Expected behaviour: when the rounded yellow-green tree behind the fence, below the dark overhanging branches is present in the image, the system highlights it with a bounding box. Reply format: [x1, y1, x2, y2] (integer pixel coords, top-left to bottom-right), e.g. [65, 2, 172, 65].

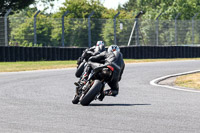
[9, 8, 52, 46]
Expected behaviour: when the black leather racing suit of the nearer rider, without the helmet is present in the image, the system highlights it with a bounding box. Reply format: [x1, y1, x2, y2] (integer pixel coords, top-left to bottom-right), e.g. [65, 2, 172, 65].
[88, 51, 125, 96]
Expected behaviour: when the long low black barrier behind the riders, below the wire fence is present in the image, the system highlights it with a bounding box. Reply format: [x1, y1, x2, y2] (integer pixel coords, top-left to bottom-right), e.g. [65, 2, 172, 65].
[0, 46, 200, 62]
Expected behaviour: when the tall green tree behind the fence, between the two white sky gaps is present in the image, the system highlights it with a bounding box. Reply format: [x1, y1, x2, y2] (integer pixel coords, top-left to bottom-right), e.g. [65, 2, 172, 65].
[52, 0, 105, 47]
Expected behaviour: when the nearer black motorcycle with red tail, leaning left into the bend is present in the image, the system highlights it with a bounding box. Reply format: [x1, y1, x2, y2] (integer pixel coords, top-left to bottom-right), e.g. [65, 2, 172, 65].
[72, 65, 114, 106]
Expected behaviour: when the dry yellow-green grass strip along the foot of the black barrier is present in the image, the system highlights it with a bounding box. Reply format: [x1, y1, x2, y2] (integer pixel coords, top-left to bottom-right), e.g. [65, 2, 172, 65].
[0, 58, 200, 72]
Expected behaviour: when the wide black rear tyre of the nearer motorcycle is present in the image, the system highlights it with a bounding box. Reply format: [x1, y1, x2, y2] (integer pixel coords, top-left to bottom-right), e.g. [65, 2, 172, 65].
[80, 80, 103, 106]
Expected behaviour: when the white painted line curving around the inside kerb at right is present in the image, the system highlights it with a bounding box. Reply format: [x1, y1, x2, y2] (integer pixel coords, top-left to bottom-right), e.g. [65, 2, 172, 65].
[150, 70, 200, 93]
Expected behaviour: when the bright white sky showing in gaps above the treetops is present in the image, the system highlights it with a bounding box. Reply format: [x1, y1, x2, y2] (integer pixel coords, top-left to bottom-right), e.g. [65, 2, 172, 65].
[37, 0, 129, 12]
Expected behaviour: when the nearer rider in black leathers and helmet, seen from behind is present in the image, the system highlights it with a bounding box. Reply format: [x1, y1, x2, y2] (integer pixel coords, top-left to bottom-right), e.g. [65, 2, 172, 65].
[80, 45, 125, 101]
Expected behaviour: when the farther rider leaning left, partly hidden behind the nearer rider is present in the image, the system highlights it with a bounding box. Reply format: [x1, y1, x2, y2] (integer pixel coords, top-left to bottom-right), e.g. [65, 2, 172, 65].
[75, 41, 105, 77]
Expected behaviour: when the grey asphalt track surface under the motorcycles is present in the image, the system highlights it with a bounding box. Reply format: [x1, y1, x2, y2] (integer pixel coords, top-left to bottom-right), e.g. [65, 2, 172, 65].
[0, 60, 200, 133]
